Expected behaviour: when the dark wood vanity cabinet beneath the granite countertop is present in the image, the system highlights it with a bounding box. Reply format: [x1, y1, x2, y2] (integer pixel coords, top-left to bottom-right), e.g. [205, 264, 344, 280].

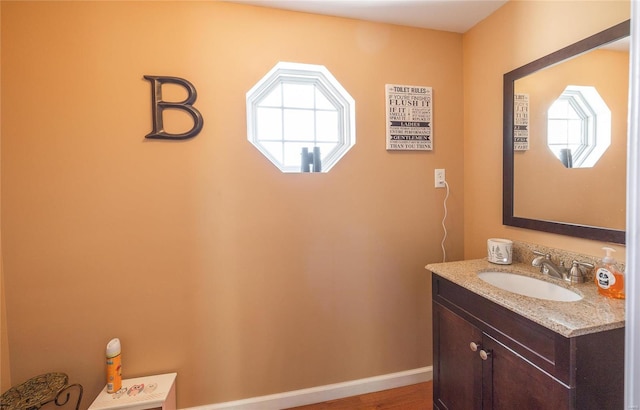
[433, 274, 624, 410]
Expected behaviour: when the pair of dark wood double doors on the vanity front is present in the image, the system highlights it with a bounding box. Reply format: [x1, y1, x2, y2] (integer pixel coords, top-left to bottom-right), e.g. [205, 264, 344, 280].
[434, 303, 571, 410]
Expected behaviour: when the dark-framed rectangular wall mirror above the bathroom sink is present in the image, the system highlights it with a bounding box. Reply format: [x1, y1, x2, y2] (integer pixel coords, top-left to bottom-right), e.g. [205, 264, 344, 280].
[503, 20, 630, 244]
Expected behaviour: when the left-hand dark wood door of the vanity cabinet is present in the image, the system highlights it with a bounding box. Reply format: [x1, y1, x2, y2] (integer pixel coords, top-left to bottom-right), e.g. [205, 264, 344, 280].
[433, 303, 482, 410]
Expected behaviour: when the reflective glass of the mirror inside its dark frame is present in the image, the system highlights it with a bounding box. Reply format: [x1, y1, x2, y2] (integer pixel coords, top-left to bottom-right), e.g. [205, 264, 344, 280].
[514, 36, 629, 229]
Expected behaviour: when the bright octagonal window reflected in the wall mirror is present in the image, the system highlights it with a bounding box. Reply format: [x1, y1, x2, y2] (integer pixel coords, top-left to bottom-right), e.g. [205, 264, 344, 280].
[547, 85, 611, 168]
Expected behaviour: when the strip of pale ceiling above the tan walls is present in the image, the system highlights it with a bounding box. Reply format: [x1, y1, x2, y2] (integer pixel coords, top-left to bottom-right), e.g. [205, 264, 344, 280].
[227, 0, 507, 33]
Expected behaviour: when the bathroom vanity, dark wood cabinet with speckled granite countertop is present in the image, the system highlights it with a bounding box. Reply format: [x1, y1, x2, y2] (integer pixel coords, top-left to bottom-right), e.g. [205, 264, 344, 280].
[427, 259, 624, 410]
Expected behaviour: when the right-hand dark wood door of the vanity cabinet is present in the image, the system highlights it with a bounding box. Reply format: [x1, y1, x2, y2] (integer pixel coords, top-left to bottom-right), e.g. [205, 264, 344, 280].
[476, 334, 573, 410]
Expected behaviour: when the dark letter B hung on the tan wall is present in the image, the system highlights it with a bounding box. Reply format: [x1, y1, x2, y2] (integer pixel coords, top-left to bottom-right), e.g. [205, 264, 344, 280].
[144, 75, 204, 140]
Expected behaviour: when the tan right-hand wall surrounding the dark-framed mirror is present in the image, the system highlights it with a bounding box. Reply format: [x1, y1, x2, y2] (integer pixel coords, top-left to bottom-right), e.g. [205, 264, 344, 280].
[463, 1, 630, 260]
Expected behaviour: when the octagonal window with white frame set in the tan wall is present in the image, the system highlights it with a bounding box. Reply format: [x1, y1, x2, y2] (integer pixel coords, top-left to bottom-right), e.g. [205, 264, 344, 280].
[247, 62, 356, 172]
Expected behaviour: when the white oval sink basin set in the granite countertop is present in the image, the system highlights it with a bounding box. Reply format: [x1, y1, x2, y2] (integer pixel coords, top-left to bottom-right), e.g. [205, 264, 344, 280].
[478, 272, 582, 302]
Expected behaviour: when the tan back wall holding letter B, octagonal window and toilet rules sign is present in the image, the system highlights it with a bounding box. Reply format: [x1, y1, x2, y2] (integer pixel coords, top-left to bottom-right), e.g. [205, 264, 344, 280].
[1, 1, 462, 407]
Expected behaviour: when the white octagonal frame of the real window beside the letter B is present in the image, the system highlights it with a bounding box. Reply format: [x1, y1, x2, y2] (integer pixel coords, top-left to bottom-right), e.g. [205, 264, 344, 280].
[246, 62, 356, 172]
